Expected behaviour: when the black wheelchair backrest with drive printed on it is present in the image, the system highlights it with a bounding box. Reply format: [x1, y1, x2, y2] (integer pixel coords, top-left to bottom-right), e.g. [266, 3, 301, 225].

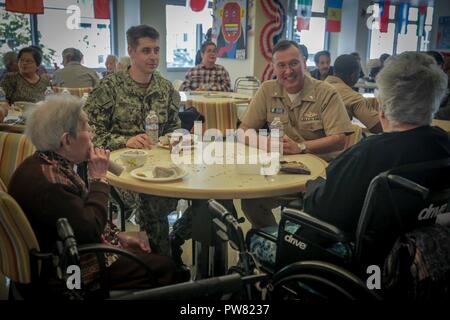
[354, 158, 450, 269]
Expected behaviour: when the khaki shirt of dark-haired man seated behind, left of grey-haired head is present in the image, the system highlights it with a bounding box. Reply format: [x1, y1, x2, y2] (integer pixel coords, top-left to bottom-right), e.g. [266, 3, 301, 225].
[325, 76, 379, 129]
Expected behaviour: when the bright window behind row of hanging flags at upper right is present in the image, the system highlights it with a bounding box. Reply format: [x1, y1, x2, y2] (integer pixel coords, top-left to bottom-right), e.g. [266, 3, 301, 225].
[369, 6, 433, 59]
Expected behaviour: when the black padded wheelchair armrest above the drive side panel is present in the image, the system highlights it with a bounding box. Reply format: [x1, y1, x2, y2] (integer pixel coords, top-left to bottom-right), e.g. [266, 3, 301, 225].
[282, 208, 350, 242]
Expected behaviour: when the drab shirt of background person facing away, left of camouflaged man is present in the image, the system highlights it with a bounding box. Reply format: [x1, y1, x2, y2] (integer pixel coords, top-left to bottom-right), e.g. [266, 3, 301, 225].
[53, 61, 100, 88]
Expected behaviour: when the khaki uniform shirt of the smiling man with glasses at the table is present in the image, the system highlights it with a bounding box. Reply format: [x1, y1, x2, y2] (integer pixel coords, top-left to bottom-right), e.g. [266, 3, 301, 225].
[242, 76, 353, 142]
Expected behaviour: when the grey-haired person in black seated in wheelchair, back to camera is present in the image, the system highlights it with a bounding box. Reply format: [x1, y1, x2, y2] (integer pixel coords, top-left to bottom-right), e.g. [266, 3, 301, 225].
[304, 52, 450, 234]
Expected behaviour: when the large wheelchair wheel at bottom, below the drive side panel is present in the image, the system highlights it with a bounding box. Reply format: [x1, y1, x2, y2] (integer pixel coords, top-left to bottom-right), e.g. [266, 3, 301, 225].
[270, 261, 381, 302]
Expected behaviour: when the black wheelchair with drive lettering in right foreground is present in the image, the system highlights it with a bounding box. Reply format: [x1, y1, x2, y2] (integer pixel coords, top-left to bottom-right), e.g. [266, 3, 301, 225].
[113, 159, 450, 303]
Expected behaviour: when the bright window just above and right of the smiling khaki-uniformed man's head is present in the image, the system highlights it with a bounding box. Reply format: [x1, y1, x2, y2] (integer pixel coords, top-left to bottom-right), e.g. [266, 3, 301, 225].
[293, 0, 328, 66]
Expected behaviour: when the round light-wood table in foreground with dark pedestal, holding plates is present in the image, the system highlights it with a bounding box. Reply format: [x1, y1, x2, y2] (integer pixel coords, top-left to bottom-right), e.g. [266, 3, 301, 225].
[107, 142, 327, 279]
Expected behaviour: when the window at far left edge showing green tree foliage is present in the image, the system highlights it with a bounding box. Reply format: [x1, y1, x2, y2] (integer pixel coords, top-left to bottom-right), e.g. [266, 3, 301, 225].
[0, 0, 31, 68]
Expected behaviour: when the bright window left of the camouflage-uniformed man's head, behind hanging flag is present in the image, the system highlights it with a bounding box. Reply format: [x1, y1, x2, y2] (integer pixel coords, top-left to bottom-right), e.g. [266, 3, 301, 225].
[37, 0, 111, 68]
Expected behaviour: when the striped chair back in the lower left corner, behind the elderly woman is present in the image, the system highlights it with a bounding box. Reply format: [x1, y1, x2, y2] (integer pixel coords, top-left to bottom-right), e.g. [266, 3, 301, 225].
[0, 192, 39, 284]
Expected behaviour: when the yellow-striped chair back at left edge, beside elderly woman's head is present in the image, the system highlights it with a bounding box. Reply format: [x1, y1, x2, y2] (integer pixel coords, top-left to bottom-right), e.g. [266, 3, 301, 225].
[0, 132, 35, 186]
